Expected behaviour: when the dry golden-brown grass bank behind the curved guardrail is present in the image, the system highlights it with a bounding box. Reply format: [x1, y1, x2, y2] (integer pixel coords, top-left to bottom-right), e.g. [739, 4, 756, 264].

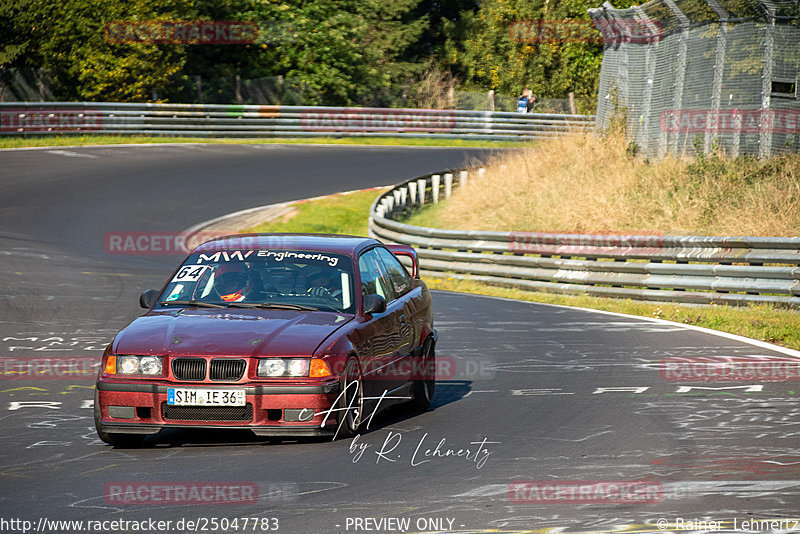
[428, 133, 800, 236]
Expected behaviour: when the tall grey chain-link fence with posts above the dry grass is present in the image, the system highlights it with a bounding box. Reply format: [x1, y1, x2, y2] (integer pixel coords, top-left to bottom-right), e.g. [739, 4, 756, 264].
[589, 0, 800, 157]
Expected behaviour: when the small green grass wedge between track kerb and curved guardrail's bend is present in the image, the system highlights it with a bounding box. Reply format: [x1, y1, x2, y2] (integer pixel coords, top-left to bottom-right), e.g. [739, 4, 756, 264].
[242, 189, 379, 236]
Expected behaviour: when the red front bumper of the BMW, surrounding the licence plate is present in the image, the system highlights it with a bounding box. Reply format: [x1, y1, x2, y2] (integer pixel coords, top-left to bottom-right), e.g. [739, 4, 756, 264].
[96, 379, 339, 436]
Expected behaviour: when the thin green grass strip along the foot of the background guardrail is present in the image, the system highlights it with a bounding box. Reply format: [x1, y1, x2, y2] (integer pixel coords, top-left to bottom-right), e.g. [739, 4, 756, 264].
[0, 135, 528, 149]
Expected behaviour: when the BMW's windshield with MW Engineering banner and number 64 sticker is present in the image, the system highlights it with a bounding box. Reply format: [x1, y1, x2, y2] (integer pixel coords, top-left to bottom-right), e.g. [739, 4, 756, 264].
[156, 250, 355, 313]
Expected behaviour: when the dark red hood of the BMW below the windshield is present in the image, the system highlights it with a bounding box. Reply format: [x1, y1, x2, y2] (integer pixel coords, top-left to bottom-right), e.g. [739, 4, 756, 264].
[113, 309, 353, 356]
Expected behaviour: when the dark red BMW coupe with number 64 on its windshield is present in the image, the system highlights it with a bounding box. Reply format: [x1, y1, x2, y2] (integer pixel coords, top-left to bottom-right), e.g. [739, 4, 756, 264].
[94, 234, 436, 446]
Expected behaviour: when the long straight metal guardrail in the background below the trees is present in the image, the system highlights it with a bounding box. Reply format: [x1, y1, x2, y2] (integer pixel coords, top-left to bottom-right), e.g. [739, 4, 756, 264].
[0, 102, 594, 140]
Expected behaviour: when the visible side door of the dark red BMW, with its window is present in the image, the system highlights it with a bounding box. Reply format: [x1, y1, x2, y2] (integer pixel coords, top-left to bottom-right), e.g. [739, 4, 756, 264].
[358, 248, 404, 396]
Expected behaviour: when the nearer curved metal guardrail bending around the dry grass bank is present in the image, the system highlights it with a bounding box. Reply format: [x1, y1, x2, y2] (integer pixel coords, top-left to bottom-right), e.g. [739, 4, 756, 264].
[369, 169, 800, 308]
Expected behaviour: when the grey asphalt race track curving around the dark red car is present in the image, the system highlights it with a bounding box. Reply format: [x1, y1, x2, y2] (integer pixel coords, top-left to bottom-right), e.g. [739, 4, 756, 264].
[0, 145, 800, 534]
